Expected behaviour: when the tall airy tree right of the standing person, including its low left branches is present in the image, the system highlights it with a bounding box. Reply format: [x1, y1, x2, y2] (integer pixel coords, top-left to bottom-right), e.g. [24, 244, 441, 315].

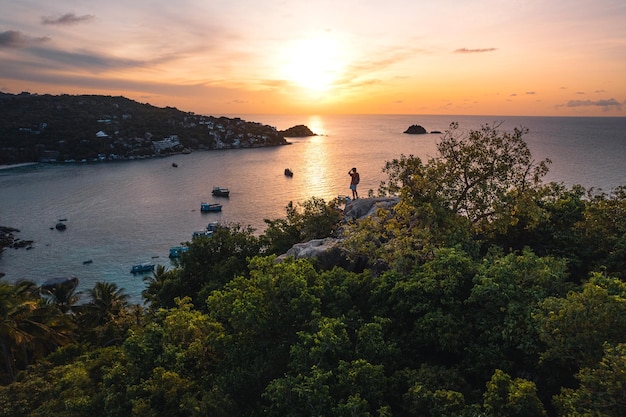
[381, 123, 550, 234]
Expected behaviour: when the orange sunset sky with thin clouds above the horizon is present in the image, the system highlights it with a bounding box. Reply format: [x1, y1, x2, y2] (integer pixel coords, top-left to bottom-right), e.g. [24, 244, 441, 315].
[0, 0, 626, 117]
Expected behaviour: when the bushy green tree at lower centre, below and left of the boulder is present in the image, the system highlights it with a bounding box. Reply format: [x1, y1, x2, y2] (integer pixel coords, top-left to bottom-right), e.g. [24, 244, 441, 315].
[207, 256, 322, 414]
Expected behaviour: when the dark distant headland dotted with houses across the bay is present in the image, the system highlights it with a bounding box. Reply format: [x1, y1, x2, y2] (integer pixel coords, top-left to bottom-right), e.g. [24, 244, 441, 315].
[0, 93, 288, 164]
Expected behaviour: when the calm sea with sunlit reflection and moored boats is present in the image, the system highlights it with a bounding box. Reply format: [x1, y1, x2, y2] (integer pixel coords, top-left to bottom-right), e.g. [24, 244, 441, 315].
[0, 115, 626, 304]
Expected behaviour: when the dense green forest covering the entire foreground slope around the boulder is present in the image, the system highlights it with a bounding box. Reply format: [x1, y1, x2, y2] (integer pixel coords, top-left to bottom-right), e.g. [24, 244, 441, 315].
[0, 124, 626, 417]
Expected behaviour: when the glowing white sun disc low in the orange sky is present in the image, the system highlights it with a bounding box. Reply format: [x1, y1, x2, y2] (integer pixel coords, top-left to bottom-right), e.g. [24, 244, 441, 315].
[280, 36, 345, 92]
